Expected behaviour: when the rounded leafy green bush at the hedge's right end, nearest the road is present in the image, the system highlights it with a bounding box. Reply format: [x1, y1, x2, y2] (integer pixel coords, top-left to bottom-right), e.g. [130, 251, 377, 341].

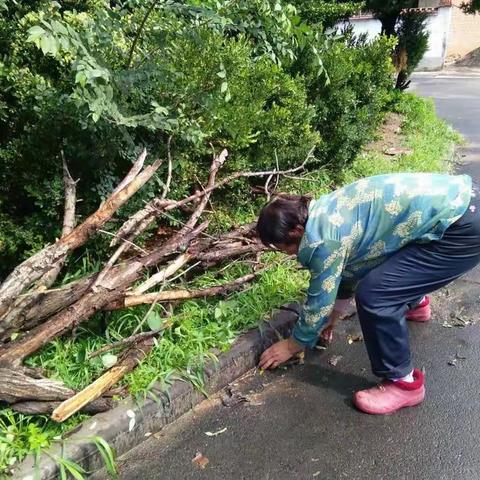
[302, 32, 394, 172]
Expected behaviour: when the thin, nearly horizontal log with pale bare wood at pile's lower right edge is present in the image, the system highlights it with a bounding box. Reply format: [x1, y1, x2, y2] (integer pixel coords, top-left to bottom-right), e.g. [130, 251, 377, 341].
[105, 273, 256, 310]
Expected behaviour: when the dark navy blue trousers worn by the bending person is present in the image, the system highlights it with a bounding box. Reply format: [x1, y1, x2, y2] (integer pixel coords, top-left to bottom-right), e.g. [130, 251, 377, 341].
[355, 188, 480, 379]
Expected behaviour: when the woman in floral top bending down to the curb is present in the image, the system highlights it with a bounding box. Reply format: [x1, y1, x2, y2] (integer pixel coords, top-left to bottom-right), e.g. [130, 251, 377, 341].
[257, 173, 480, 414]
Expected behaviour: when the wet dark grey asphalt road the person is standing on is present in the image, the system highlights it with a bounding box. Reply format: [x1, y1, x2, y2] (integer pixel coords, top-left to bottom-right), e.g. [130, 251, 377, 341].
[94, 74, 480, 480]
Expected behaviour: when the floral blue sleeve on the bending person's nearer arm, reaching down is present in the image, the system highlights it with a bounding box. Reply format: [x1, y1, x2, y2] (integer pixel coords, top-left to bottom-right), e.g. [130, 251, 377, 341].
[292, 241, 346, 348]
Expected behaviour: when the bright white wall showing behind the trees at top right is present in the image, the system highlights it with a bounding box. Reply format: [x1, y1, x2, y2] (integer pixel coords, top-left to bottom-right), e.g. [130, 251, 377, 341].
[337, 7, 452, 70]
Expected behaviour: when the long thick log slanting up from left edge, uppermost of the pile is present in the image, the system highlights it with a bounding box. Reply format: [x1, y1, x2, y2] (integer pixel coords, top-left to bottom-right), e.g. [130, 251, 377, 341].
[0, 152, 161, 318]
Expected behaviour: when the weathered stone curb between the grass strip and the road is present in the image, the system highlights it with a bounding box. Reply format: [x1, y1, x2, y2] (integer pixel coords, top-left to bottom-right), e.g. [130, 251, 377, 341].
[13, 304, 299, 480]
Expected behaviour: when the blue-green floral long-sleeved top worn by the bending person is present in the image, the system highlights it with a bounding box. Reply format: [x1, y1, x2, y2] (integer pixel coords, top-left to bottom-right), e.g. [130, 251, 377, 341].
[293, 173, 472, 347]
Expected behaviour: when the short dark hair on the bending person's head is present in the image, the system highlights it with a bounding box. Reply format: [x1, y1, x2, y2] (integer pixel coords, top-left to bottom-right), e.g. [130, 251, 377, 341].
[257, 194, 311, 245]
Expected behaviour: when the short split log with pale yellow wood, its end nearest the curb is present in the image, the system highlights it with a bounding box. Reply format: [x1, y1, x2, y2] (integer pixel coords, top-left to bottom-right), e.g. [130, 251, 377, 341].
[52, 338, 154, 422]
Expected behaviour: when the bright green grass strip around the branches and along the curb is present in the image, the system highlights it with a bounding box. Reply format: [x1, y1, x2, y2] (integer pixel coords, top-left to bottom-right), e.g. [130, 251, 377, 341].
[0, 94, 461, 478]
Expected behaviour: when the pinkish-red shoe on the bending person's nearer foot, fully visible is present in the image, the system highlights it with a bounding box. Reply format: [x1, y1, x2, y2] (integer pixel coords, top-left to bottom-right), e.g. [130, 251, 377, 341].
[353, 369, 425, 415]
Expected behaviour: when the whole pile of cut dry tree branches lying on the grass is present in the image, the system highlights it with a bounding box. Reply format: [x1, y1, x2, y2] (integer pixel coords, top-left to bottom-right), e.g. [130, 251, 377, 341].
[0, 145, 311, 421]
